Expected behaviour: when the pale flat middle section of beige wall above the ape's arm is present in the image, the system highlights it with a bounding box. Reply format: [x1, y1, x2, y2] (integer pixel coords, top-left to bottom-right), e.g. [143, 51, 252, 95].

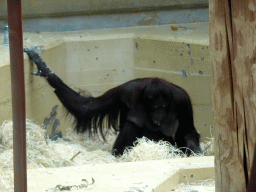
[63, 35, 134, 96]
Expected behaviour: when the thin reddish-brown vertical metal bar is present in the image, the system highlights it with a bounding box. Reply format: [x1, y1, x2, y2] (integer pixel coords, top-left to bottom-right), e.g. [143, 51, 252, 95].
[7, 0, 27, 192]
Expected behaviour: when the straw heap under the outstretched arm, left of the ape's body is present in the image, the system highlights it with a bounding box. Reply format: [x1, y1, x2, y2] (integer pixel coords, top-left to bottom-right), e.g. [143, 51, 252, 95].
[0, 120, 115, 168]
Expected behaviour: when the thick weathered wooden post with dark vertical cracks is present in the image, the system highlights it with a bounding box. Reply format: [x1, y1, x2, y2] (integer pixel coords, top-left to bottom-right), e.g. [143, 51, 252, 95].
[209, 0, 256, 191]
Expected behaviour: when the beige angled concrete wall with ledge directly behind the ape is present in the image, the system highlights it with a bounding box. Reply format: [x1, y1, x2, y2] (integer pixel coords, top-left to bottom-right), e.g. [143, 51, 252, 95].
[0, 23, 212, 142]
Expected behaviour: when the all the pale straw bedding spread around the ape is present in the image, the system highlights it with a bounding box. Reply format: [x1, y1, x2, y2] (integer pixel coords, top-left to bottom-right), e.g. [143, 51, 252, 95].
[0, 120, 214, 191]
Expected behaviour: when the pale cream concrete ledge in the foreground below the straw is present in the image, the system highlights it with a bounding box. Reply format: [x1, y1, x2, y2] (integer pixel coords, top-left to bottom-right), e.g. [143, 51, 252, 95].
[17, 156, 214, 192]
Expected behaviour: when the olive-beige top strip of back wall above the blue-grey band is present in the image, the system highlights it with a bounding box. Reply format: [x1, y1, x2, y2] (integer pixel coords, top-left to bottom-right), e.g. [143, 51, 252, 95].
[0, 0, 208, 20]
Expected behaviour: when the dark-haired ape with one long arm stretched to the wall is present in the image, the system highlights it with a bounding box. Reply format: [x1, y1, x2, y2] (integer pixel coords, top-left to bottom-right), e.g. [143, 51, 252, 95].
[24, 48, 201, 155]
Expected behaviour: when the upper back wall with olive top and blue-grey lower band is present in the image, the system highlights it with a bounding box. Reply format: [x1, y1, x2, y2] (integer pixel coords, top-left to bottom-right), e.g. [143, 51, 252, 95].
[0, 0, 209, 32]
